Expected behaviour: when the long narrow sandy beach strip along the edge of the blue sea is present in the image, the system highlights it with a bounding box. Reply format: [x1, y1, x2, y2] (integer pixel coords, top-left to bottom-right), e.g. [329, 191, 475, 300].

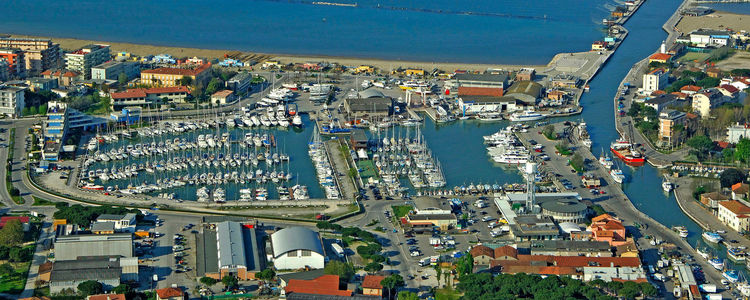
[4, 34, 545, 72]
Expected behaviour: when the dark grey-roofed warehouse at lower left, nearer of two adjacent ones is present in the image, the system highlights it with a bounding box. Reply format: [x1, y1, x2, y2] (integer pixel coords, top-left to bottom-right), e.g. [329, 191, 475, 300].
[48, 257, 138, 293]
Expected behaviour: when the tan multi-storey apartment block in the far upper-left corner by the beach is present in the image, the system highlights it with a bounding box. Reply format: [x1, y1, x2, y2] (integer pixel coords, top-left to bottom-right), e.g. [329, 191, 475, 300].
[0, 37, 62, 75]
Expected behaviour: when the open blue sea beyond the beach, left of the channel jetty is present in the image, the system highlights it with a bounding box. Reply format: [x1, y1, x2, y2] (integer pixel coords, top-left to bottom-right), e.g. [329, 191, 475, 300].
[0, 0, 622, 64]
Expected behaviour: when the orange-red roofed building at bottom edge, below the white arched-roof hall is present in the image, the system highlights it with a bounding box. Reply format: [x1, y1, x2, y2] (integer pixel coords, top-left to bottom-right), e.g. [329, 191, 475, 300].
[284, 275, 354, 300]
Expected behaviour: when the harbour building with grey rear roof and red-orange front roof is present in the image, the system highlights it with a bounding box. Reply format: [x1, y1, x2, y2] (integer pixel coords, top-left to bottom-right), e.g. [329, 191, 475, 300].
[451, 73, 508, 97]
